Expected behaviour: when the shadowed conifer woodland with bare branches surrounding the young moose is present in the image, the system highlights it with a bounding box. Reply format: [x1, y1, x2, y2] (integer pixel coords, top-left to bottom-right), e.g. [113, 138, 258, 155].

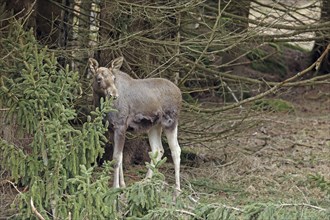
[0, 0, 330, 219]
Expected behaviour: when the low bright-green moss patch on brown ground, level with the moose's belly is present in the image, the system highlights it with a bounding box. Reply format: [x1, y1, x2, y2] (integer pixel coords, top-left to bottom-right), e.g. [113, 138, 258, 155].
[252, 99, 295, 112]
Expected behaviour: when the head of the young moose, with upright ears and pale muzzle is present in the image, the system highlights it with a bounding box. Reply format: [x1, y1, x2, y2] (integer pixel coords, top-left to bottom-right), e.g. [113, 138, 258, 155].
[88, 57, 124, 99]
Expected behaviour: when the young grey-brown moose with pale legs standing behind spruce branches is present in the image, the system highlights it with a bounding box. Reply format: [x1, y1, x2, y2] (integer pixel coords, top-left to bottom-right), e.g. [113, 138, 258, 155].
[89, 57, 182, 192]
